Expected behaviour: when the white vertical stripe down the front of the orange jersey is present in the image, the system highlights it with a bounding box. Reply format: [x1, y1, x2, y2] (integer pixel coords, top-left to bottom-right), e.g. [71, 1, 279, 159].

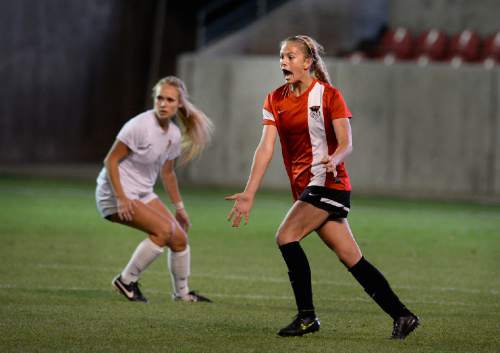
[307, 82, 328, 186]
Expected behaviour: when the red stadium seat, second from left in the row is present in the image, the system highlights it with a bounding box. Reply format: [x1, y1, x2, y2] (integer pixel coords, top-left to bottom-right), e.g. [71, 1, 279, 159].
[415, 29, 449, 65]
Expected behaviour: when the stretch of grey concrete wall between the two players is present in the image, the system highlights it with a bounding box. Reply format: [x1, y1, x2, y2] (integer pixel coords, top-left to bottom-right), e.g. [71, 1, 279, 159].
[178, 56, 288, 188]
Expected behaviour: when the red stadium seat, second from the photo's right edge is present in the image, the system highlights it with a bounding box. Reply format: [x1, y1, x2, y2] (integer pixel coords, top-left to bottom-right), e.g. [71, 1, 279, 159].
[449, 29, 481, 65]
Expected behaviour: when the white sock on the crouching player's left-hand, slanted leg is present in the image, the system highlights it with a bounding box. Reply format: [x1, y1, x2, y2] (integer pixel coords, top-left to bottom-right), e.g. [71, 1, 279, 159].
[121, 238, 163, 284]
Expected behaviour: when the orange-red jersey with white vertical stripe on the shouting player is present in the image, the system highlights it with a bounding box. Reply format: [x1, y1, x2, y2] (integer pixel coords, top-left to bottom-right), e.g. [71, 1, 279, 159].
[262, 80, 352, 199]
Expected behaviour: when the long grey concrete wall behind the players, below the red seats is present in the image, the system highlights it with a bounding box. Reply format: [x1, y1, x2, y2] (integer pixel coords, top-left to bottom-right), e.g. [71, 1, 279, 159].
[178, 55, 500, 200]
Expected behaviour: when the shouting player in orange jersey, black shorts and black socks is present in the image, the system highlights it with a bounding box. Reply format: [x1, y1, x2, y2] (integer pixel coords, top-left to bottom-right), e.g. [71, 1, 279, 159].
[226, 35, 419, 339]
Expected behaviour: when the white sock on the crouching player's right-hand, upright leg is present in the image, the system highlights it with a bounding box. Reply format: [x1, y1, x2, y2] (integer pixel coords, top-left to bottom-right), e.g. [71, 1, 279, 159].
[168, 245, 191, 297]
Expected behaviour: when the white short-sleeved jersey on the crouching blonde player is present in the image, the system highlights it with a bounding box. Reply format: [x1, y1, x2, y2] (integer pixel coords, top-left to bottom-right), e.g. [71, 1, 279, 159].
[97, 110, 182, 199]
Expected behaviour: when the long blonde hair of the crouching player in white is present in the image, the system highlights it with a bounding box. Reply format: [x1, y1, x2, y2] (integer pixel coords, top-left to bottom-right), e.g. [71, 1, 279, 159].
[153, 76, 214, 163]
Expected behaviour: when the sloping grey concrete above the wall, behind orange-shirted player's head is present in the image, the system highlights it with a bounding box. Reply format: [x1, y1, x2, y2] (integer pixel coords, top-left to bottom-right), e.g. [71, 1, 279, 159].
[199, 0, 389, 56]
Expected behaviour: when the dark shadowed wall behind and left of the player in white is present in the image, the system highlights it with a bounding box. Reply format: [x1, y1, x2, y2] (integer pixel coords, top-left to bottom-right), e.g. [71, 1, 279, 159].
[0, 0, 208, 164]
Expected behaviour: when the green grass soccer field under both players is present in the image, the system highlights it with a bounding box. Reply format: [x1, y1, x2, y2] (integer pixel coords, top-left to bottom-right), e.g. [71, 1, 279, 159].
[0, 176, 500, 353]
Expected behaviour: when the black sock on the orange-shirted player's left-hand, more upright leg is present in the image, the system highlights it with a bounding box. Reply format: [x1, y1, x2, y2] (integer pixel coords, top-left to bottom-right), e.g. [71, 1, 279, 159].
[279, 241, 315, 316]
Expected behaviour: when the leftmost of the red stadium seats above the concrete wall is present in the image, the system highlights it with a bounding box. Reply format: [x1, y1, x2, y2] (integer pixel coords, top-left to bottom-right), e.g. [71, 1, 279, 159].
[379, 27, 413, 62]
